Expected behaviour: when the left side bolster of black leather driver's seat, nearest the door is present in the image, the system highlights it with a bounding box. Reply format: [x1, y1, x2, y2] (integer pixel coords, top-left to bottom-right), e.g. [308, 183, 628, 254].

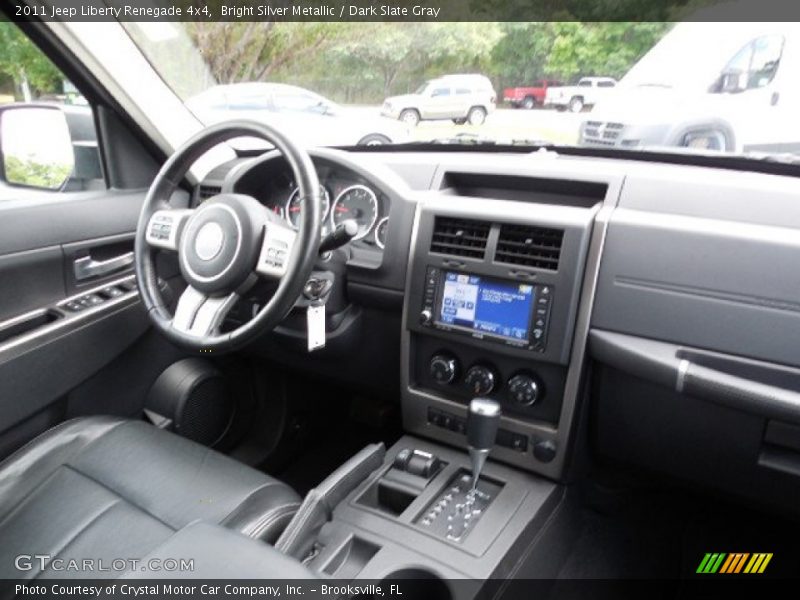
[0, 416, 125, 519]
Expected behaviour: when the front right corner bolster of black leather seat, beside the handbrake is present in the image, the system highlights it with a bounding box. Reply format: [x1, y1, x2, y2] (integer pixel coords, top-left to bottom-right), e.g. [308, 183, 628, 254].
[221, 480, 301, 544]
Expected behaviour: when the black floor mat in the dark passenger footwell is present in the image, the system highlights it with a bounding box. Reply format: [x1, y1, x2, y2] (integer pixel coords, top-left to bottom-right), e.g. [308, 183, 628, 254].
[559, 482, 800, 580]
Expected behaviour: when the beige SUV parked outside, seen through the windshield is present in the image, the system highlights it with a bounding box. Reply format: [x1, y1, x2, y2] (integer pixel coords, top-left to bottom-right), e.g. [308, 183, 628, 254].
[381, 75, 497, 126]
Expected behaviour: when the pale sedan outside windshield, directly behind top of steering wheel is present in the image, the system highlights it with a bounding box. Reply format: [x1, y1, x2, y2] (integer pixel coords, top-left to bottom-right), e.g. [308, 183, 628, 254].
[186, 82, 408, 146]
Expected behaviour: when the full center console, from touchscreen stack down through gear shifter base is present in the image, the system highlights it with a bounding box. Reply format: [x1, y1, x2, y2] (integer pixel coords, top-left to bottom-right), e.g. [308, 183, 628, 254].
[279, 165, 619, 600]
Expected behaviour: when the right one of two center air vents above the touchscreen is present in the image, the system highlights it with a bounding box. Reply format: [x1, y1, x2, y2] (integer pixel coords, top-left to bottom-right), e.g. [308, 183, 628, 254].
[494, 225, 564, 271]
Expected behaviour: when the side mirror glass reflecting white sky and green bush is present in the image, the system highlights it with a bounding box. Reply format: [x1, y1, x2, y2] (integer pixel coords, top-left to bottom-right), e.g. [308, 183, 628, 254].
[0, 104, 75, 190]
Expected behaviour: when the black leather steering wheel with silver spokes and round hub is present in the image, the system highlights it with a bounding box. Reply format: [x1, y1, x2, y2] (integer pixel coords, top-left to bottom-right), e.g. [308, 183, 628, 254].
[134, 120, 322, 353]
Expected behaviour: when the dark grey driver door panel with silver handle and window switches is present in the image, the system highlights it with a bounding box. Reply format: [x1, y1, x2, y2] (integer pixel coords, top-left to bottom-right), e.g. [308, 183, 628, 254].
[0, 190, 148, 456]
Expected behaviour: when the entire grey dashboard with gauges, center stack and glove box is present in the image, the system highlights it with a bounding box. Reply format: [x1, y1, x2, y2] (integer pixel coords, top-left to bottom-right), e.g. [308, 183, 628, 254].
[195, 148, 800, 509]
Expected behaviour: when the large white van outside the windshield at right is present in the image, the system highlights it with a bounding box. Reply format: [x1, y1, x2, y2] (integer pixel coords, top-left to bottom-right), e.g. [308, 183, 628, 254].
[580, 22, 800, 153]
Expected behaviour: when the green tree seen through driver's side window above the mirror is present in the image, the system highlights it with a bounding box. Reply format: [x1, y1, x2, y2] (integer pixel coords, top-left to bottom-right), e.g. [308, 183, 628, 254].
[0, 21, 64, 101]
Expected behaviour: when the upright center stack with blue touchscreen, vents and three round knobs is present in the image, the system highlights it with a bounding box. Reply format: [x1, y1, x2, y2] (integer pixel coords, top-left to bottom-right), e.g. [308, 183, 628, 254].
[402, 177, 603, 477]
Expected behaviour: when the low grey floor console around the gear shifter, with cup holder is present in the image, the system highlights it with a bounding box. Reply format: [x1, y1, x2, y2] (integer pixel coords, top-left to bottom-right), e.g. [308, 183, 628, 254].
[305, 436, 563, 599]
